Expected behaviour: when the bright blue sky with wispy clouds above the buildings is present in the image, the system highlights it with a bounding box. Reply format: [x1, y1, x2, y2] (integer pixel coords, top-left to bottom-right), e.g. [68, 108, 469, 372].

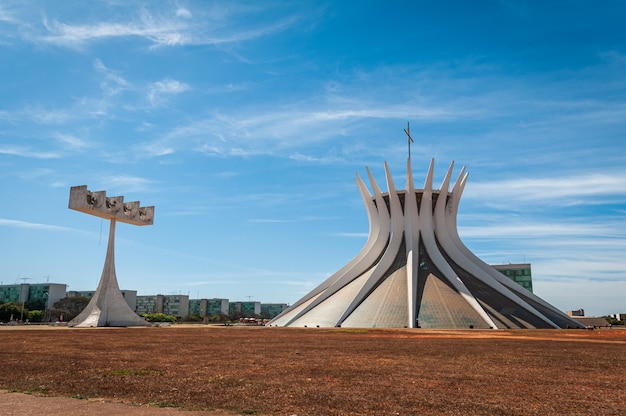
[0, 0, 626, 315]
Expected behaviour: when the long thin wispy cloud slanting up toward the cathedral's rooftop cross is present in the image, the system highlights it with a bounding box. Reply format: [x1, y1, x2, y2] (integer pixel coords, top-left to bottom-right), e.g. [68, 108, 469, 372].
[141, 100, 459, 158]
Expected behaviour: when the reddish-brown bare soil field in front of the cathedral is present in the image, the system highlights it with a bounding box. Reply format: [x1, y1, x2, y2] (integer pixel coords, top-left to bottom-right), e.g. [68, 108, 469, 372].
[0, 326, 626, 416]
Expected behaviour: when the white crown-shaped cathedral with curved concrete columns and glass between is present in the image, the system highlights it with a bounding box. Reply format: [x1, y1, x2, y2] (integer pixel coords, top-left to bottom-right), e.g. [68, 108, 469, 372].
[269, 158, 582, 329]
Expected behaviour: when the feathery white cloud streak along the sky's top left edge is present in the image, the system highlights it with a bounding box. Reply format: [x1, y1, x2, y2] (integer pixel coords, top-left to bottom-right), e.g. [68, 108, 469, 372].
[14, 3, 302, 49]
